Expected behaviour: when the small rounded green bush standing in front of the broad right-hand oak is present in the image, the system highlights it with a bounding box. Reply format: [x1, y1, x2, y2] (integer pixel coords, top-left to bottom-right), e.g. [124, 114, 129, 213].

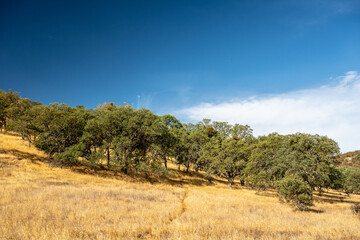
[277, 176, 312, 210]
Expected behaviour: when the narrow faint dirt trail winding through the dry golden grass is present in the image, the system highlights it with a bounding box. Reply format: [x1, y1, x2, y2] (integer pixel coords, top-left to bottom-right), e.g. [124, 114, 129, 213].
[138, 188, 189, 239]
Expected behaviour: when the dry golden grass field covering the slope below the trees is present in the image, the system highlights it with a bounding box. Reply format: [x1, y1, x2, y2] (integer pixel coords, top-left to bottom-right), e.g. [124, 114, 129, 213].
[0, 134, 360, 240]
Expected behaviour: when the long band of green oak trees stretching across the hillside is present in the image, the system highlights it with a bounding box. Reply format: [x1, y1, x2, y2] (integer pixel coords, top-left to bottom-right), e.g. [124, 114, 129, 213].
[0, 90, 360, 209]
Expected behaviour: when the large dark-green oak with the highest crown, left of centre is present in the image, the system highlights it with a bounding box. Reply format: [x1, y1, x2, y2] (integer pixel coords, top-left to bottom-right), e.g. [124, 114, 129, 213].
[80, 104, 169, 173]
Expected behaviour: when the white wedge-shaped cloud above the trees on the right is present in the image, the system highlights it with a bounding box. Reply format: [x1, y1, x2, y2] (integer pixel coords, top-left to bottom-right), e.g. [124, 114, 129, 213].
[177, 71, 360, 152]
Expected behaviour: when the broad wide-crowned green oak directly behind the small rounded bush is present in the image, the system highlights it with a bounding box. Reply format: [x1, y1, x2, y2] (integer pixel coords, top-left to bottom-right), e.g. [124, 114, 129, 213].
[245, 133, 341, 192]
